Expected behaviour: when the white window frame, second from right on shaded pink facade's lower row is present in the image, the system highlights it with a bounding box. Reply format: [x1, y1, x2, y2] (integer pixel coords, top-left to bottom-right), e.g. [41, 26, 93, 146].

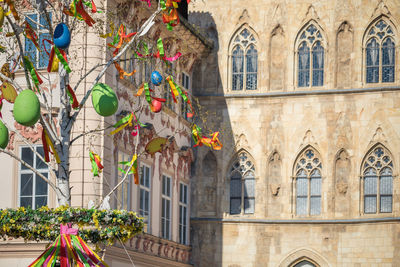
[160, 174, 172, 240]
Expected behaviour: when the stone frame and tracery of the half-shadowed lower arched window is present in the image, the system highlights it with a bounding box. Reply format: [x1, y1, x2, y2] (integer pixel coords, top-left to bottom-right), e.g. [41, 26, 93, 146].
[227, 149, 257, 215]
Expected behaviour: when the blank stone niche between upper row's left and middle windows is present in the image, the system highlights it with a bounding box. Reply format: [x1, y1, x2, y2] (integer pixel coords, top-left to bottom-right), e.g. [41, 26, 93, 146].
[269, 24, 287, 91]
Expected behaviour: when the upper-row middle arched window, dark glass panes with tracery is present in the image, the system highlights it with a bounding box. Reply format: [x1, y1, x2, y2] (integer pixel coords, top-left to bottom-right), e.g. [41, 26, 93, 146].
[297, 24, 324, 87]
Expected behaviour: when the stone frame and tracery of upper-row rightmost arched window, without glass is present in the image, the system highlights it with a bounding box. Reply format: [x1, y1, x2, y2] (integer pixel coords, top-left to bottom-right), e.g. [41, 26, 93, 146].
[361, 15, 399, 87]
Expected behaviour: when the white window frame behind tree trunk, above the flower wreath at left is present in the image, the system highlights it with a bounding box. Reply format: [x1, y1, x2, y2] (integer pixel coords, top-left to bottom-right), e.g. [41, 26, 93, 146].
[18, 145, 49, 209]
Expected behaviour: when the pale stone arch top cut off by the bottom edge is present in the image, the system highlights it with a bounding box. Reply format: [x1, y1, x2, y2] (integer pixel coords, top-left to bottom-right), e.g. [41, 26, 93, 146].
[278, 248, 330, 267]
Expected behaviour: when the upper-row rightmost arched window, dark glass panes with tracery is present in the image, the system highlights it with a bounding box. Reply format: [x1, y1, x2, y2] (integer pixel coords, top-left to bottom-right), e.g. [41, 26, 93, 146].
[365, 19, 395, 83]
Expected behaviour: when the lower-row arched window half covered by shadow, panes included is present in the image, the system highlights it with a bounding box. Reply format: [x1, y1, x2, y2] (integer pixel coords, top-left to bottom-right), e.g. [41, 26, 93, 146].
[229, 152, 255, 214]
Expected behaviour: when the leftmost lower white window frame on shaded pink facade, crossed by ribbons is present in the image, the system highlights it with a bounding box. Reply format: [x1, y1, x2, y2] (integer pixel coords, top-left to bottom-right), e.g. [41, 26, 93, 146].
[116, 151, 132, 211]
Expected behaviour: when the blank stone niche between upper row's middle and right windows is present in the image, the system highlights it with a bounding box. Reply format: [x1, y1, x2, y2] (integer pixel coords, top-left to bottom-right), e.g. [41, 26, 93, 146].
[335, 21, 354, 88]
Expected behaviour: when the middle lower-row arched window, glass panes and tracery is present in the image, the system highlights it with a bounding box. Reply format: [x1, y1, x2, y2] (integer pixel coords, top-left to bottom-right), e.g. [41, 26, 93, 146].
[294, 147, 322, 215]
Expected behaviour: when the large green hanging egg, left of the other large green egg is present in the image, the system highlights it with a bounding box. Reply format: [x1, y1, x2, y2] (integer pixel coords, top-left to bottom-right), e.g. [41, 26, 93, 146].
[13, 89, 40, 126]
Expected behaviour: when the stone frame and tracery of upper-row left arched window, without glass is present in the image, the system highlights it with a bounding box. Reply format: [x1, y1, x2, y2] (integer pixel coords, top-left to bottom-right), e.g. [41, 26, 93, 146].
[227, 23, 261, 93]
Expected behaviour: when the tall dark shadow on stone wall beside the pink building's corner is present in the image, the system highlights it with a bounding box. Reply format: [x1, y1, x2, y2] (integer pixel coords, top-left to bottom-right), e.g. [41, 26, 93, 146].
[189, 12, 233, 267]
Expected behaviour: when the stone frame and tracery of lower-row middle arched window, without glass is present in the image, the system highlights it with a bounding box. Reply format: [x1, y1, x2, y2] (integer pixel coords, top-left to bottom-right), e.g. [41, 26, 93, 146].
[292, 145, 324, 217]
